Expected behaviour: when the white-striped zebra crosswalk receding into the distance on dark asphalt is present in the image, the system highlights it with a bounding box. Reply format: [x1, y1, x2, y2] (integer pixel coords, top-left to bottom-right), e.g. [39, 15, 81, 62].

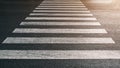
[0, 0, 120, 66]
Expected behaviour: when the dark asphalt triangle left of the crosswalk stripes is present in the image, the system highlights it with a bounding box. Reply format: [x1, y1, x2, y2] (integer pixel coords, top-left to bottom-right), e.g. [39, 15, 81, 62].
[0, 0, 42, 42]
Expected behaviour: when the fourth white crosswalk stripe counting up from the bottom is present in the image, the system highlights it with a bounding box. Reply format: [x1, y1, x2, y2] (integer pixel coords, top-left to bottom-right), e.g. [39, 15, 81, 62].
[20, 22, 101, 26]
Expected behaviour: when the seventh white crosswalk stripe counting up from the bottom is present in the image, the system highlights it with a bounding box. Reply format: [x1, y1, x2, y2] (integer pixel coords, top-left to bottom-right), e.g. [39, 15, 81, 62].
[33, 10, 90, 13]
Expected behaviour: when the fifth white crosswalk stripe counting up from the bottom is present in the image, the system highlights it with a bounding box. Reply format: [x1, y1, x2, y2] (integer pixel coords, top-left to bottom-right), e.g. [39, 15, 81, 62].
[25, 17, 96, 20]
